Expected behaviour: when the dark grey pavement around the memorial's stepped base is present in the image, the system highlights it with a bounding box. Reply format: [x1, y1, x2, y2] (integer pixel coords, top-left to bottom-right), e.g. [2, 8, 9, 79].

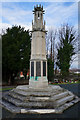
[0, 84, 80, 120]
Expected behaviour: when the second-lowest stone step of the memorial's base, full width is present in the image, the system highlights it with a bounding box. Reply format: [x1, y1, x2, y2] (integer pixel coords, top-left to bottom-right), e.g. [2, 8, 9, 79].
[3, 92, 74, 108]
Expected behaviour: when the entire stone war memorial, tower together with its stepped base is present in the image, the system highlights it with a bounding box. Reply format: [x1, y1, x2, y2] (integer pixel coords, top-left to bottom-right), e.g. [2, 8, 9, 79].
[0, 5, 80, 114]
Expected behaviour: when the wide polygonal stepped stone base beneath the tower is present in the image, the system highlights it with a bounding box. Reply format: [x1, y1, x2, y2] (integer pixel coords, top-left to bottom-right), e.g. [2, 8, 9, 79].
[0, 85, 80, 114]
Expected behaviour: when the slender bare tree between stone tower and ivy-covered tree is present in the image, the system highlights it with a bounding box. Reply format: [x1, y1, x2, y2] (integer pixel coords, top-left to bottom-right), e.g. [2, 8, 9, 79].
[46, 29, 56, 81]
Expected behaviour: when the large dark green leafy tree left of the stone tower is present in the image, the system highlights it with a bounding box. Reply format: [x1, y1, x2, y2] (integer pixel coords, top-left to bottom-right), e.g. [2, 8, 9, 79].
[2, 26, 31, 83]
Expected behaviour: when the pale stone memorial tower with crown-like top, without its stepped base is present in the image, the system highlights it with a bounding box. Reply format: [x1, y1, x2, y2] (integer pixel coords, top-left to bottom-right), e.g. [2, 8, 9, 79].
[29, 5, 48, 88]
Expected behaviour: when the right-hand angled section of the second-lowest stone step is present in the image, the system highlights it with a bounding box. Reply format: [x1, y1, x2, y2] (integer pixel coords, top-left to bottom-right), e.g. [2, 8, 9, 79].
[54, 95, 75, 107]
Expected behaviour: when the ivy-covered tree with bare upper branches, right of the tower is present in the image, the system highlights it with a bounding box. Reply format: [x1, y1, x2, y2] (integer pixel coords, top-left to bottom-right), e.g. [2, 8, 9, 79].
[56, 24, 76, 78]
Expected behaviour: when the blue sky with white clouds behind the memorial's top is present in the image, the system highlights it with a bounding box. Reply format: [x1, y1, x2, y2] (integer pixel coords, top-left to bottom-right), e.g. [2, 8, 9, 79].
[0, 0, 78, 68]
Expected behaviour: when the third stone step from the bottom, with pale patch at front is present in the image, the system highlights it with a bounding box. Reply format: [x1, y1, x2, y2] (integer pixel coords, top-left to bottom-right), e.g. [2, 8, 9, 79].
[9, 91, 69, 102]
